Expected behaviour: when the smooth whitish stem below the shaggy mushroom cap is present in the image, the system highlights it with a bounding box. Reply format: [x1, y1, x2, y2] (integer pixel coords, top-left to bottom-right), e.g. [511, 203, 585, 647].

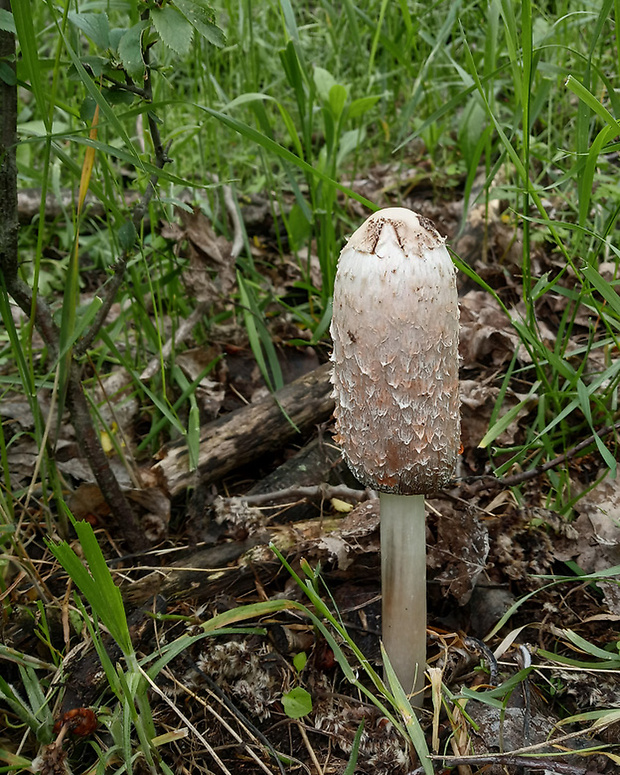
[379, 493, 426, 707]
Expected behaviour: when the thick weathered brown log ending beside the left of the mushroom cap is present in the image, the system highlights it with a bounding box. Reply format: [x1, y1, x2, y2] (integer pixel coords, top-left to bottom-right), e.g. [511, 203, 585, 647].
[153, 363, 334, 496]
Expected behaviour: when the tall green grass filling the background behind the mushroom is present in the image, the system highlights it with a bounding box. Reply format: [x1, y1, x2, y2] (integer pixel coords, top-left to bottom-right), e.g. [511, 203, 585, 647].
[2, 0, 620, 556]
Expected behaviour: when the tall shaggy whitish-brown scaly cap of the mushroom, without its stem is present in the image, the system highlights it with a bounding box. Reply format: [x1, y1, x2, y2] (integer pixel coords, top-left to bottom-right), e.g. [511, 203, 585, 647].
[331, 207, 460, 495]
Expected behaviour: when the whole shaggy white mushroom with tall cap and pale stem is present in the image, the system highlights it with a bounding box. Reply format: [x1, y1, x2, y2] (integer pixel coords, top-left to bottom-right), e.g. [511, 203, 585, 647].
[331, 207, 460, 705]
